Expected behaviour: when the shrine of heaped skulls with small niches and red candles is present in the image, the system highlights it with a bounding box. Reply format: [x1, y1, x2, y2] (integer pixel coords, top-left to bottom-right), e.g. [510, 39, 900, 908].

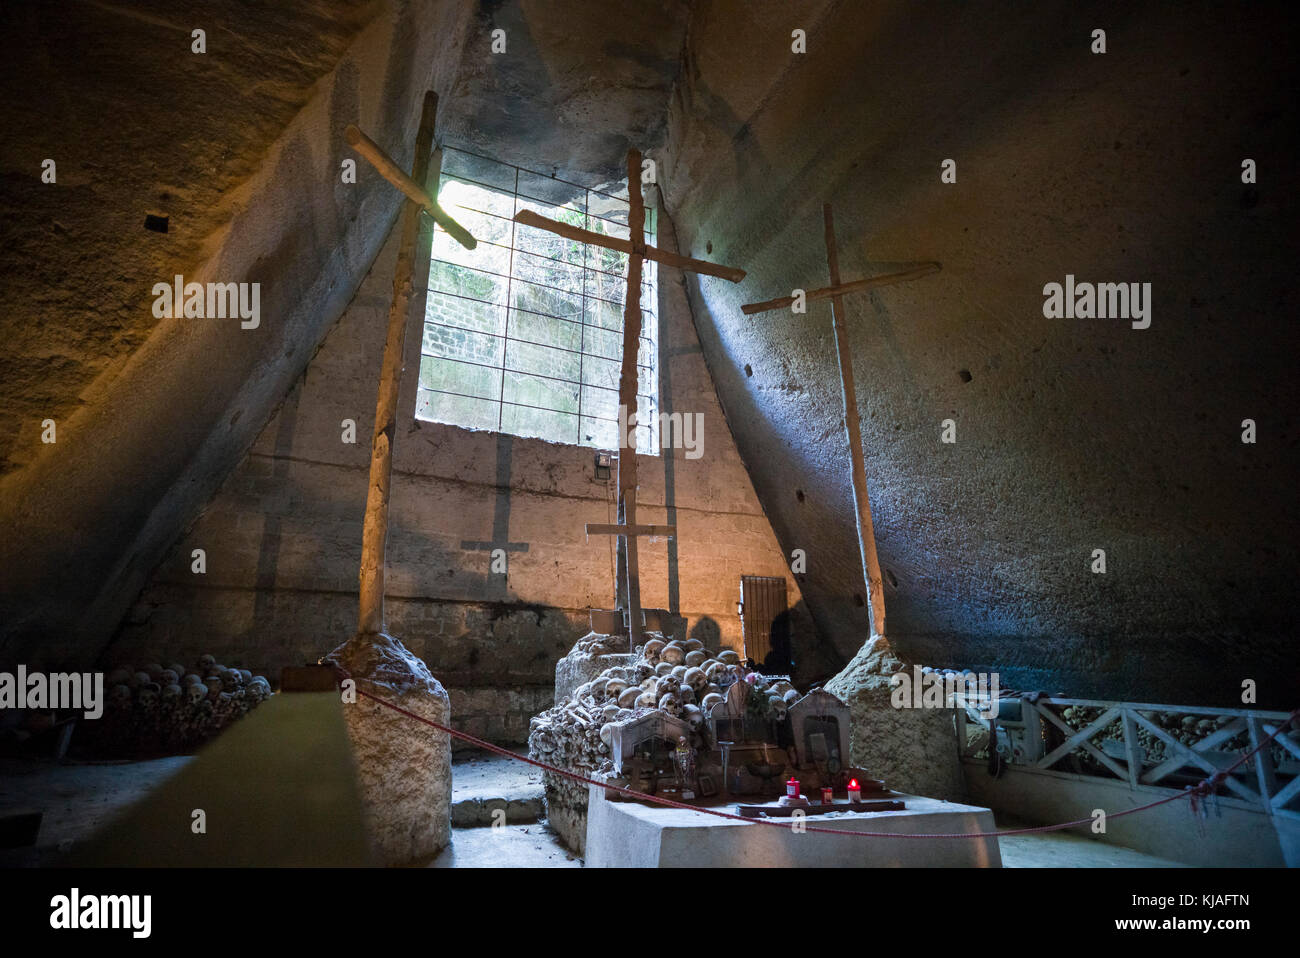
[529, 636, 904, 818]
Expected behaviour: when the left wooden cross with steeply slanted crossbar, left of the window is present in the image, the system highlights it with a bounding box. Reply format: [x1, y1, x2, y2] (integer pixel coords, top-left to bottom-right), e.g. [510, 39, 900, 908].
[347, 91, 475, 634]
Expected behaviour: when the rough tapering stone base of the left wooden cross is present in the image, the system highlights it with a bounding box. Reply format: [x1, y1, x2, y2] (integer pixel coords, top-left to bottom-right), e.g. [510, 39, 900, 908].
[321, 633, 451, 864]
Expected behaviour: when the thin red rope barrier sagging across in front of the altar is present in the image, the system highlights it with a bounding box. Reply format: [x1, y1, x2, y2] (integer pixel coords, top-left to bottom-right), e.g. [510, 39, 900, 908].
[335, 668, 1300, 838]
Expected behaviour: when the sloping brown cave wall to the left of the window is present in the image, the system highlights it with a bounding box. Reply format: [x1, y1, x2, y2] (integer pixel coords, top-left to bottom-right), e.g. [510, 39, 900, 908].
[0, 0, 472, 668]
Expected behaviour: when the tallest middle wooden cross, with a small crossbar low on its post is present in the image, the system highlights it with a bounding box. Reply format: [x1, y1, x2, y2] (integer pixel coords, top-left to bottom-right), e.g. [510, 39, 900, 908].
[515, 149, 745, 647]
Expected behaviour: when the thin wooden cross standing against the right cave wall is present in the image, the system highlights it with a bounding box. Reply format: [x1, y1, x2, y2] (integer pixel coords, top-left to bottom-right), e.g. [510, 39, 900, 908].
[741, 203, 940, 636]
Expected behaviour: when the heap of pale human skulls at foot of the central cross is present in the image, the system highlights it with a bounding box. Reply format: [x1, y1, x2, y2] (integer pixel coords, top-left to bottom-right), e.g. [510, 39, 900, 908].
[528, 638, 801, 771]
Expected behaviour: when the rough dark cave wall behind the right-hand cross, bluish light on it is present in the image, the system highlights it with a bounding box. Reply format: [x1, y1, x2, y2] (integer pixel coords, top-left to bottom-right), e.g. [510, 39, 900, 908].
[662, 0, 1300, 707]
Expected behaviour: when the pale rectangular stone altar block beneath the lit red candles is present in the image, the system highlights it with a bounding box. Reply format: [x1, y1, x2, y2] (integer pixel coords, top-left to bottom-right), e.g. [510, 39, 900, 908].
[586, 785, 1002, 868]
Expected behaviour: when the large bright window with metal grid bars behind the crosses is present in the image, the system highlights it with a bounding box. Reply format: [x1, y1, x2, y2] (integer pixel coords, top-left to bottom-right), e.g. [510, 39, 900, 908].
[415, 146, 659, 454]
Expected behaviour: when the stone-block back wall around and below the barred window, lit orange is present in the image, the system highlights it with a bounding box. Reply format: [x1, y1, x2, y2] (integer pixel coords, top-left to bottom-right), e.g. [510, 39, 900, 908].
[105, 210, 835, 744]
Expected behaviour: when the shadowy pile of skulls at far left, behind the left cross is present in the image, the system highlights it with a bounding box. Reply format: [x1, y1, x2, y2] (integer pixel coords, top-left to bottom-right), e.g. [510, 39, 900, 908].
[86, 655, 272, 755]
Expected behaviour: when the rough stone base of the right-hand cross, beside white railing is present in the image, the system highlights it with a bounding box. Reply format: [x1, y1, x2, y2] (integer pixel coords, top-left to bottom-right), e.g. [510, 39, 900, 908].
[826, 638, 966, 801]
